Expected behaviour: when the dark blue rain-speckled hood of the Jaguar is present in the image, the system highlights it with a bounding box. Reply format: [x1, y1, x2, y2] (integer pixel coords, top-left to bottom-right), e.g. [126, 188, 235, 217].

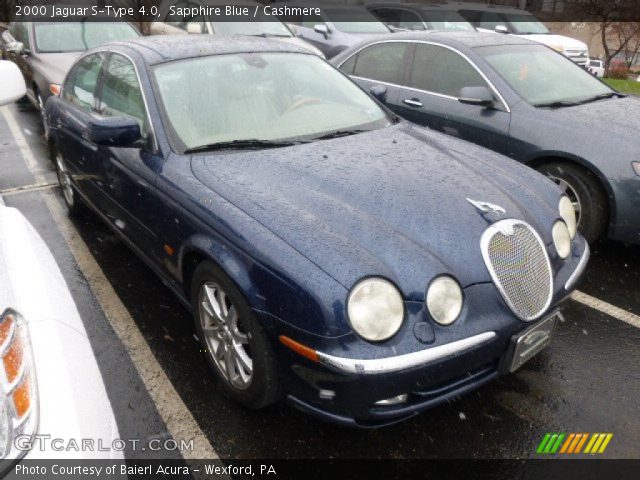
[191, 122, 560, 300]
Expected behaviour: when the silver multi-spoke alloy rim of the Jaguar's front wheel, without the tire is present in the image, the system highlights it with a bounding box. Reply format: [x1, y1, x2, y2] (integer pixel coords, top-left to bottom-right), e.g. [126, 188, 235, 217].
[198, 282, 253, 390]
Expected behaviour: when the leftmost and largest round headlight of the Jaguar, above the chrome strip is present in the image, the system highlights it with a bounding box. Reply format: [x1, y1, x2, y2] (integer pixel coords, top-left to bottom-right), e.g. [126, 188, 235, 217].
[347, 278, 404, 342]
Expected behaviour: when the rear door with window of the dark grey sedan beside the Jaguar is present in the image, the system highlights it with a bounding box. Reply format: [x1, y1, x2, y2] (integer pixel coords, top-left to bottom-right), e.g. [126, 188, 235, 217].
[340, 41, 411, 113]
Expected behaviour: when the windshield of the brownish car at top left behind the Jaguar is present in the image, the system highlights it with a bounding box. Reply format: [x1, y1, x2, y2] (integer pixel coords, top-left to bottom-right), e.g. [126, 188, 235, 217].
[35, 22, 140, 53]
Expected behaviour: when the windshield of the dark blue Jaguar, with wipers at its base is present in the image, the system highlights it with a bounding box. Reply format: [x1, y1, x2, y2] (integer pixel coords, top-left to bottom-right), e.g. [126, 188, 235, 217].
[154, 52, 392, 151]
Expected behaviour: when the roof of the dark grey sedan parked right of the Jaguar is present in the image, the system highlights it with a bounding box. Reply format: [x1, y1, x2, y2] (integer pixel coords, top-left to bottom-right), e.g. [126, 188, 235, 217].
[356, 31, 540, 48]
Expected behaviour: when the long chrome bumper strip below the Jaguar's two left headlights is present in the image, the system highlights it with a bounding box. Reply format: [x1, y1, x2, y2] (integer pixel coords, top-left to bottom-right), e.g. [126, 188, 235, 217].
[317, 332, 497, 375]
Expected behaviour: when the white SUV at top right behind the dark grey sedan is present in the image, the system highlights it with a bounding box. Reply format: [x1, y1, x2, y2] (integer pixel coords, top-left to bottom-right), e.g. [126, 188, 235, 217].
[446, 1, 589, 68]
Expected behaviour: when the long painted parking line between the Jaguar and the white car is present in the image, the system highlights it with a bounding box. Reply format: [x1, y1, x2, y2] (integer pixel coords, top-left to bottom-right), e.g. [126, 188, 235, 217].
[0, 107, 218, 460]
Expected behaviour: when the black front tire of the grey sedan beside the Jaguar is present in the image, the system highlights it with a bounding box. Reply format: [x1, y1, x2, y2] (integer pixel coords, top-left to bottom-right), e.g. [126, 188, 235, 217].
[538, 162, 609, 244]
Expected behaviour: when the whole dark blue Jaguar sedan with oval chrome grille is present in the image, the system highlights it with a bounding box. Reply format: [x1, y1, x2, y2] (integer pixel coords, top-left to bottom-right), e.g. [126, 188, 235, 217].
[47, 36, 589, 426]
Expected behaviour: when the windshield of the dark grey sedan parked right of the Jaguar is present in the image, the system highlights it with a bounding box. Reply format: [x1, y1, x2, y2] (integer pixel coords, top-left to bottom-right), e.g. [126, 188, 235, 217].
[476, 45, 615, 106]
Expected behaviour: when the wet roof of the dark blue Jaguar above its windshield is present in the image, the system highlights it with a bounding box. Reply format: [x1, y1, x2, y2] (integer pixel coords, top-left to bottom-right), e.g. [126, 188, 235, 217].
[101, 34, 313, 65]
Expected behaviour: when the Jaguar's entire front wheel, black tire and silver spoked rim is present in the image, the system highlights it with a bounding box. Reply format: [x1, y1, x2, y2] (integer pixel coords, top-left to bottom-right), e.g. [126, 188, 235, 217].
[191, 261, 282, 409]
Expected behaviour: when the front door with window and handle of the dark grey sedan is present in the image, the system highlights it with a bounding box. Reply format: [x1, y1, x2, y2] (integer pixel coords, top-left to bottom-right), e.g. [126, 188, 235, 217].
[397, 43, 511, 153]
